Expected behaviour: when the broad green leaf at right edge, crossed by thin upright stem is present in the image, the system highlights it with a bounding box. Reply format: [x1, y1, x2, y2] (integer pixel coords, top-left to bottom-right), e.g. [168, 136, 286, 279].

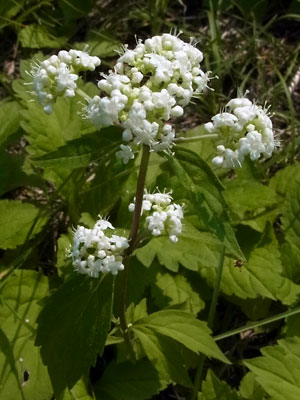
[200, 245, 300, 305]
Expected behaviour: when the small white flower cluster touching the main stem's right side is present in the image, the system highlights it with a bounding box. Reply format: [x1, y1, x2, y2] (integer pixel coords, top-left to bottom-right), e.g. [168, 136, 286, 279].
[128, 190, 183, 243]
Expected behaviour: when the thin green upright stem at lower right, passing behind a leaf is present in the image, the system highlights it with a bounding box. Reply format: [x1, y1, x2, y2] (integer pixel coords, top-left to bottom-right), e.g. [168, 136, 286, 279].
[191, 244, 225, 400]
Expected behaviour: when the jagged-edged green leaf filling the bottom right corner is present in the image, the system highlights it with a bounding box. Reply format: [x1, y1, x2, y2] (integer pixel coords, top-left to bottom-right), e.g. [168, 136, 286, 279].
[243, 337, 300, 400]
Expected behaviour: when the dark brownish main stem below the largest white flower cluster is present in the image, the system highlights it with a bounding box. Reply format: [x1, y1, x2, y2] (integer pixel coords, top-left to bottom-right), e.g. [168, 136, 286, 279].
[120, 145, 150, 336]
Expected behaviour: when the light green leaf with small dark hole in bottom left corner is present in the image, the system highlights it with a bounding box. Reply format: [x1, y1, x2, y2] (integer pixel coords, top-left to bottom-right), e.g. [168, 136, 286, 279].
[0, 270, 53, 400]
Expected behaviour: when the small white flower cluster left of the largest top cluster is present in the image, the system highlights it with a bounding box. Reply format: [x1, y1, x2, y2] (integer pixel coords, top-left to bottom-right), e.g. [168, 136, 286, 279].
[31, 50, 100, 114]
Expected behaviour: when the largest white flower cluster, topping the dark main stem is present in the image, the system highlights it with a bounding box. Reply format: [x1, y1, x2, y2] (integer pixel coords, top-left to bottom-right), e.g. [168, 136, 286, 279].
[85, 34, 209, 163]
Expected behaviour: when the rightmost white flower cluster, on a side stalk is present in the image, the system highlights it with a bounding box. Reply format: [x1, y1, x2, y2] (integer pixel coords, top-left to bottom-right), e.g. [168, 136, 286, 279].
[205, 97, 276, 168]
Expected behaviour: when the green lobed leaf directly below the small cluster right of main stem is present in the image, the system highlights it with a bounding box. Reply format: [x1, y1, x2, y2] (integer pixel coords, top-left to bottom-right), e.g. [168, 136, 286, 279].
[135, 222, 220, 272]
